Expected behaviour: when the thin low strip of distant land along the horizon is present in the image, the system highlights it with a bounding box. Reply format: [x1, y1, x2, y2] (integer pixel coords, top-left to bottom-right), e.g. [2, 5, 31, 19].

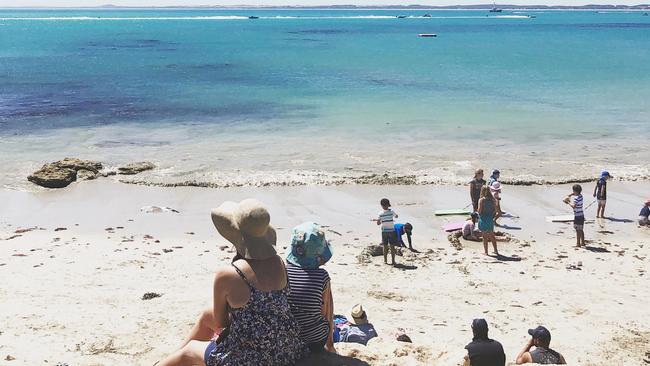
[0, 4, 650, 11]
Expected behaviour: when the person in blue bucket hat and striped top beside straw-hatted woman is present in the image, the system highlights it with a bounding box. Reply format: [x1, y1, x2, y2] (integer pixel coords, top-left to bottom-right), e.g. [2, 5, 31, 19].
[286, 222, 336, 352]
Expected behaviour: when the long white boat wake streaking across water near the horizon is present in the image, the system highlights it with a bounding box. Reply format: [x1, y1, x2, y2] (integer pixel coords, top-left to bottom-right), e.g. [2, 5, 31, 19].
[0, 15, 531, 21]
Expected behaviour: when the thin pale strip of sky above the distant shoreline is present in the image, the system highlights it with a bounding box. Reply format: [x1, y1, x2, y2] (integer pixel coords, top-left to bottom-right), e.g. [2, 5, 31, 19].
[0, 0, 647, 7]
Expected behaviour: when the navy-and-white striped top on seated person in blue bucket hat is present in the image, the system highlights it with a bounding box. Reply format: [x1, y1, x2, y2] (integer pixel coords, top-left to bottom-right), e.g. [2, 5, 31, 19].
[287, 263, 330, 344]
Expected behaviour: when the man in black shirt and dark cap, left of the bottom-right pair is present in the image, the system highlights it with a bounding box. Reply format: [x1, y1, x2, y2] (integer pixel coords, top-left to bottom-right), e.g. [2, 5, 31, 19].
[465, 319, 506, 366]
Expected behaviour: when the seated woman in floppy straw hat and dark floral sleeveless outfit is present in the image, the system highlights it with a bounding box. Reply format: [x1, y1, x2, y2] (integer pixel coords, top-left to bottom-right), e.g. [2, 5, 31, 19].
[158, 199, 307, 366]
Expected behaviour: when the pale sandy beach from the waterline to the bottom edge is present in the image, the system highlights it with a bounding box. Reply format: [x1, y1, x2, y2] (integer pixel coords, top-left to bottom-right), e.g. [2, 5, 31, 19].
[0, 181, 650, 366]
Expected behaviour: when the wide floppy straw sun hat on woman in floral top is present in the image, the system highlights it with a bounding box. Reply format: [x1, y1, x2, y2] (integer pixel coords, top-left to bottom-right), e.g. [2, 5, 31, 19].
[212, 199, 277, 259]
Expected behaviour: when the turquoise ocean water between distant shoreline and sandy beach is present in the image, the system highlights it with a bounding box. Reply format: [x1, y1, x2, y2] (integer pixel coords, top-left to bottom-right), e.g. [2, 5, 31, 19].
[0, 9, 650, 187]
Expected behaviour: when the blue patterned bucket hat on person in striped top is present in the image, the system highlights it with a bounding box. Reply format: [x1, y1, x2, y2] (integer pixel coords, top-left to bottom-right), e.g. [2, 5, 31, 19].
[287, 222, 332, 269]
